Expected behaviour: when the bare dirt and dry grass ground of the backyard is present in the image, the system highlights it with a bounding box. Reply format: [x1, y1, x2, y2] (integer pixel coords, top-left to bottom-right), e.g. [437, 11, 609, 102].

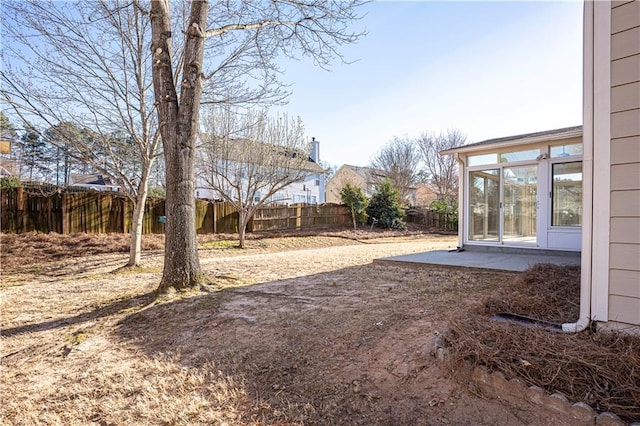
[0, 231, 596, 425]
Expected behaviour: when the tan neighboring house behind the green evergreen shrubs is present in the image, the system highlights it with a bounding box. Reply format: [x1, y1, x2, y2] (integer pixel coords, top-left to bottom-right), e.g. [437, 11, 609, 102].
[326, 164, 416, 206]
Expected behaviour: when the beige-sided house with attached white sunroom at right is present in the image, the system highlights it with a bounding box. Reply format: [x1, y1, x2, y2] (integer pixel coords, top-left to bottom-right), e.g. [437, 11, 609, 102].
[443, 0, 640, 333]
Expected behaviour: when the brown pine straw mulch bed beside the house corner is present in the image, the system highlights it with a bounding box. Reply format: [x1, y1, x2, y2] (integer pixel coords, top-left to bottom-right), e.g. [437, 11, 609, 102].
[445, 264, 640, 422]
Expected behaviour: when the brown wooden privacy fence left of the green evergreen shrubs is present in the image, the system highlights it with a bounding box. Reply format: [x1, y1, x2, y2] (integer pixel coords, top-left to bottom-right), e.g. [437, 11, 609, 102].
[0, 188, 350, 234]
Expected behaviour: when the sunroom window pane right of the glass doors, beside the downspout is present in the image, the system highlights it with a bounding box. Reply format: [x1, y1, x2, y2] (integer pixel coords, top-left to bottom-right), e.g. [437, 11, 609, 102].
[551, 161, 582, 226]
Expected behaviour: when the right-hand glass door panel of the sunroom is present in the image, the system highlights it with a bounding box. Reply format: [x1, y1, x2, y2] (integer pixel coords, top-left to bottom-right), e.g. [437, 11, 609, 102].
[502, 165, 538, 244]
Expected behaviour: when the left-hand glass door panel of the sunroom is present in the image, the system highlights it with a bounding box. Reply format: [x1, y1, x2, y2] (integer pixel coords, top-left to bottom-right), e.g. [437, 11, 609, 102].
[469, 169, 500, 241]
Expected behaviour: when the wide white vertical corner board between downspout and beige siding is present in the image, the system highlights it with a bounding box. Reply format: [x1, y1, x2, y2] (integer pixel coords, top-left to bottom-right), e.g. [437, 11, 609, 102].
[583, 0, 611, 321]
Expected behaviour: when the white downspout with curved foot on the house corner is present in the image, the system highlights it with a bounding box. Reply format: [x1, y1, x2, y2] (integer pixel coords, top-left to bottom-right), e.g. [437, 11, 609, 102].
[562, 0, 595, 333]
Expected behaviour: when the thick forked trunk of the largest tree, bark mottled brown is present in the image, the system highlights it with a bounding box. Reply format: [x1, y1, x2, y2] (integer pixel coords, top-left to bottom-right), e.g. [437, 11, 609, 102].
[151, 0, 208, 293]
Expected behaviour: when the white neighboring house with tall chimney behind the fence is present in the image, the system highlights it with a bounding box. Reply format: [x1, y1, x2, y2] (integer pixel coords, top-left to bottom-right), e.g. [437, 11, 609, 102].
[196, 138, 326, 204]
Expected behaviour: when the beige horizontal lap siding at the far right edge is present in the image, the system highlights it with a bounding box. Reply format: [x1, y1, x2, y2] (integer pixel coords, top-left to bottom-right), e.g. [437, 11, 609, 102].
[608, 1, 640, 325]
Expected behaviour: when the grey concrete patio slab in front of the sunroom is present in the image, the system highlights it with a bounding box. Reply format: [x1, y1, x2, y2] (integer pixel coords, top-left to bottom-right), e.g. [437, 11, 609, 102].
[375, 250, 580, 272]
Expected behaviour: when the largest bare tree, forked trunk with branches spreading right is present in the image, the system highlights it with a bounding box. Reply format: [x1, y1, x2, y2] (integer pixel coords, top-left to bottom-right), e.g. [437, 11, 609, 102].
[150, 0, 362, 292]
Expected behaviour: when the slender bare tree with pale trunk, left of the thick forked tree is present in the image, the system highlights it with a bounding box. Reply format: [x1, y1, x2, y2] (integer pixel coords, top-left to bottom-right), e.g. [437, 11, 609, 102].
[1, 0, 160, 266]
